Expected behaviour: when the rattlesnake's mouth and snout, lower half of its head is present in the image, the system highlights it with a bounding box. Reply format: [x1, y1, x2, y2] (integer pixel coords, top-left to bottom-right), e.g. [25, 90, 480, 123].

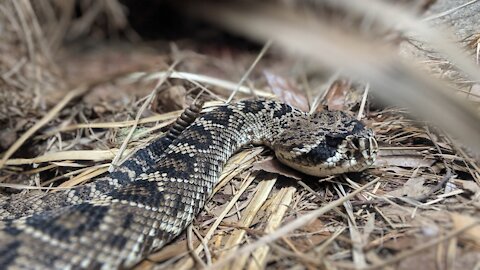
[277, 135, 378, 177]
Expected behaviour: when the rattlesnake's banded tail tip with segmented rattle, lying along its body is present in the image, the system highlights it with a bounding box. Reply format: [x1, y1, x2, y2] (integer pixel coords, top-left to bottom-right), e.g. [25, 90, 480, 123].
[0, 102, 202, 220]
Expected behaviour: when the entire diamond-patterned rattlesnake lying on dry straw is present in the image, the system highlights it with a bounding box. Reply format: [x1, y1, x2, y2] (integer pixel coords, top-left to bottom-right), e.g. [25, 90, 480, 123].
[0, 100, 378, 269]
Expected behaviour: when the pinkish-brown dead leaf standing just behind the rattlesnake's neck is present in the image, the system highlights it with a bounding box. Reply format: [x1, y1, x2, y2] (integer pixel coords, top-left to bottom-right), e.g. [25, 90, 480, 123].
[263, 70, 310, 112]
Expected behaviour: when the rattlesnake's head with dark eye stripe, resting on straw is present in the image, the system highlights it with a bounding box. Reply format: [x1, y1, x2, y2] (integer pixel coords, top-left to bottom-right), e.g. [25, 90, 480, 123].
[272, 111, 378, 176]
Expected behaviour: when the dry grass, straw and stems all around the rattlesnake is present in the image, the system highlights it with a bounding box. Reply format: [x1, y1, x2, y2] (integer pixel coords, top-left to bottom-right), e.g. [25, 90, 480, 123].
[0, 0, 480, 269]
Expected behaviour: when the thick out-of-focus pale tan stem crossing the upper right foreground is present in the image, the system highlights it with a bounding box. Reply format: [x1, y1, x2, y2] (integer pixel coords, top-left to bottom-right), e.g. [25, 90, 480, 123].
[184, 0, 480, 151]
